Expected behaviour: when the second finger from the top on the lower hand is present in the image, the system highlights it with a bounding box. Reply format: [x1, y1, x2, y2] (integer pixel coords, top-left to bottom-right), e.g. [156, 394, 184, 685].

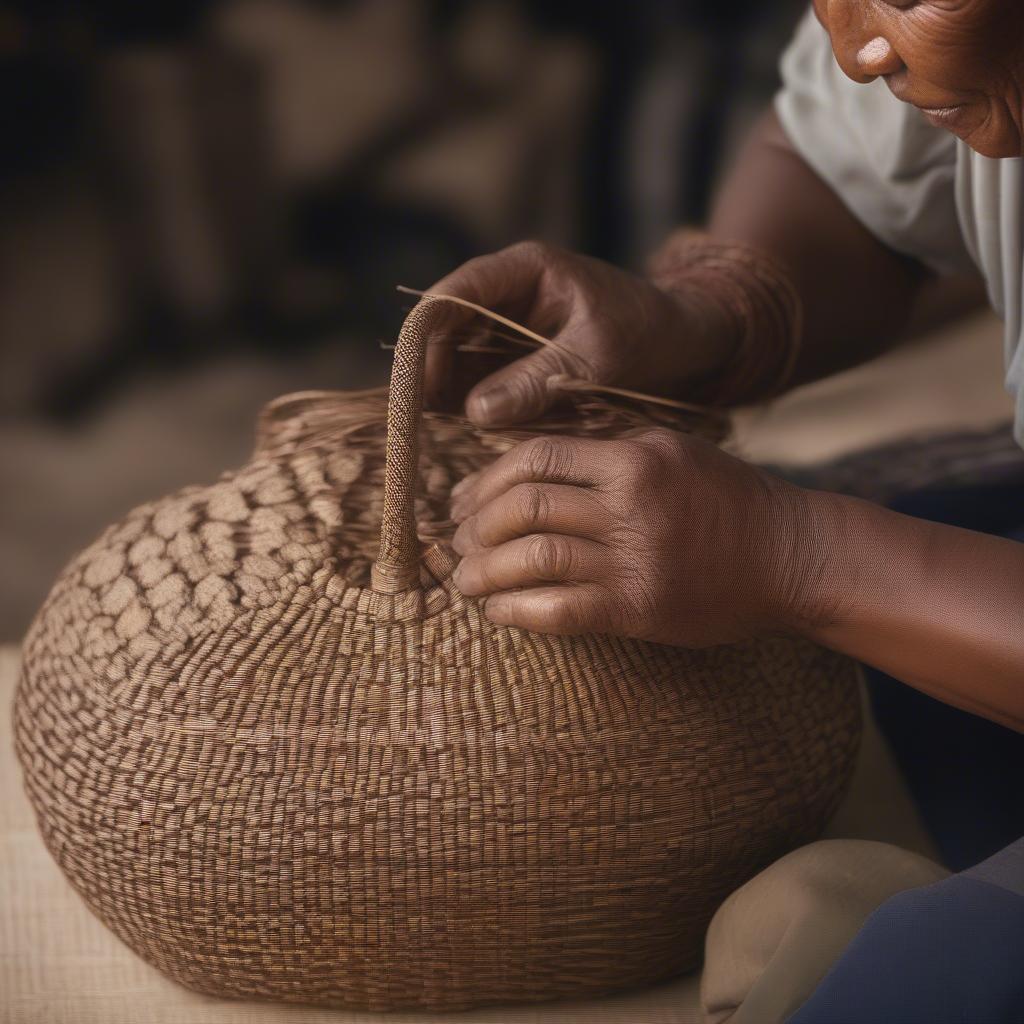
[452, 483, 611, 556]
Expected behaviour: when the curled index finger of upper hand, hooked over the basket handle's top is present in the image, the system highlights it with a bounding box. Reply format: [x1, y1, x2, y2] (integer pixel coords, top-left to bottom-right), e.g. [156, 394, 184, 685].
[424, 242, 546, 408]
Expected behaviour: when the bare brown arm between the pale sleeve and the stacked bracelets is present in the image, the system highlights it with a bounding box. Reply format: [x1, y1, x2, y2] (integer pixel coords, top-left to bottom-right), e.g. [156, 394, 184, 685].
[709, 113, 930, 383]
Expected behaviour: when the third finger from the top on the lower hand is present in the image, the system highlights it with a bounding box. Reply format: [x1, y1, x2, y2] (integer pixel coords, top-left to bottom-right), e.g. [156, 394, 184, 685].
[454, 534, 609, 597]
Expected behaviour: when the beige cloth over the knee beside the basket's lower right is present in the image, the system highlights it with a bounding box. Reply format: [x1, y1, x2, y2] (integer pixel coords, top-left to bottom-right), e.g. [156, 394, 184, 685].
[700, 840, 949, 1024]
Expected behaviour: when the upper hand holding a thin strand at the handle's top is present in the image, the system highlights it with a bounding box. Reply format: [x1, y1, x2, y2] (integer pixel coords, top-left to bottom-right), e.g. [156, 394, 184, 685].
[426, 242, 737, 426]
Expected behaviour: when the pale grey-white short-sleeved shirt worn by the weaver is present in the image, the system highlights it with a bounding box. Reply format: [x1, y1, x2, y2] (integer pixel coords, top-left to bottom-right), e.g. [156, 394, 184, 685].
[775, 12, 1024, 446]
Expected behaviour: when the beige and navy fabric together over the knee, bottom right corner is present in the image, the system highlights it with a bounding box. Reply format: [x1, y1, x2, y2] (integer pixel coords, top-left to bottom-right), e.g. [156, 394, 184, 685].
[701, 840, 1024, 1024]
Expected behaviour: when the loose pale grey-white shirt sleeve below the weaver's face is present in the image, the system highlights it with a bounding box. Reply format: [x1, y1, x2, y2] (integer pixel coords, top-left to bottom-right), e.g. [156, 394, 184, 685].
[775, 11, 977, 273]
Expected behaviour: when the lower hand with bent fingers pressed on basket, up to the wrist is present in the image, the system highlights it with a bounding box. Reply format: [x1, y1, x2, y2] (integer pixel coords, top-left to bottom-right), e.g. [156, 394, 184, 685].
[452, 430, 815, 647]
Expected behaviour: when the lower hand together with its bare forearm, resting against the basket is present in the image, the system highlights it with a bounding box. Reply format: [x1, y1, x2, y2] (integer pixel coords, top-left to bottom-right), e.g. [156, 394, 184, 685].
[452, 430, 1024, 729]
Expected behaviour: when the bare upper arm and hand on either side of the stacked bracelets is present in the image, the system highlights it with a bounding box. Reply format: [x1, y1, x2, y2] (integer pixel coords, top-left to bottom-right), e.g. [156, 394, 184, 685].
[426, 113, 974, 426]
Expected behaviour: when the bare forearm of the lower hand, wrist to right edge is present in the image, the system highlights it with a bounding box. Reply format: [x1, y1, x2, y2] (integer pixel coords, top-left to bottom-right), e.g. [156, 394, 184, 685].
[791, 492, 1024, 731]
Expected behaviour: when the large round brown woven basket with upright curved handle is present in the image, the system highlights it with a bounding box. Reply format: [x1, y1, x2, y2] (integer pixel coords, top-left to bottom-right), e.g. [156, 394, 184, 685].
[15, 302, 859, 1010]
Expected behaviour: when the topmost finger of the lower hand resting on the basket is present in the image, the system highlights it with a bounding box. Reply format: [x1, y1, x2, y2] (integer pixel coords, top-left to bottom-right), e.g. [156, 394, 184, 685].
[452, 437, 616, 523]
